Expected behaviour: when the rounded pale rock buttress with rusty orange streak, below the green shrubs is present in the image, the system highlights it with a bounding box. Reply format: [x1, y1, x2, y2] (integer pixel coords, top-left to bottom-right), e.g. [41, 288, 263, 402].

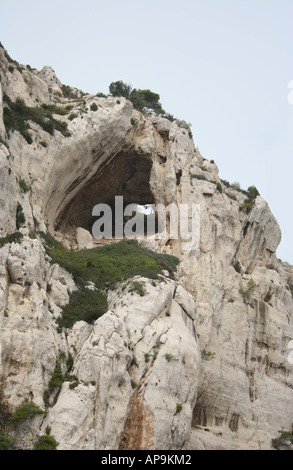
[44, 279, 200, 449]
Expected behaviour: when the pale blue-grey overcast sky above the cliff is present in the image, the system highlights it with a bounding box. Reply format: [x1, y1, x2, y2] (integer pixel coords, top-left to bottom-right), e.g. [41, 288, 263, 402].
[0, 0, 293, 264]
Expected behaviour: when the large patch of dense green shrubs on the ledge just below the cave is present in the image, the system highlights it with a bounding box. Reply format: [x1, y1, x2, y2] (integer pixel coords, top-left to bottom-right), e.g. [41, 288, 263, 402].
[41, 232, 179, 328]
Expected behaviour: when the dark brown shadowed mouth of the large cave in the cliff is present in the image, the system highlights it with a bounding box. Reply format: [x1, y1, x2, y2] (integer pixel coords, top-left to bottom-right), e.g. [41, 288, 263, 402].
[54, 151, 155, 239]
